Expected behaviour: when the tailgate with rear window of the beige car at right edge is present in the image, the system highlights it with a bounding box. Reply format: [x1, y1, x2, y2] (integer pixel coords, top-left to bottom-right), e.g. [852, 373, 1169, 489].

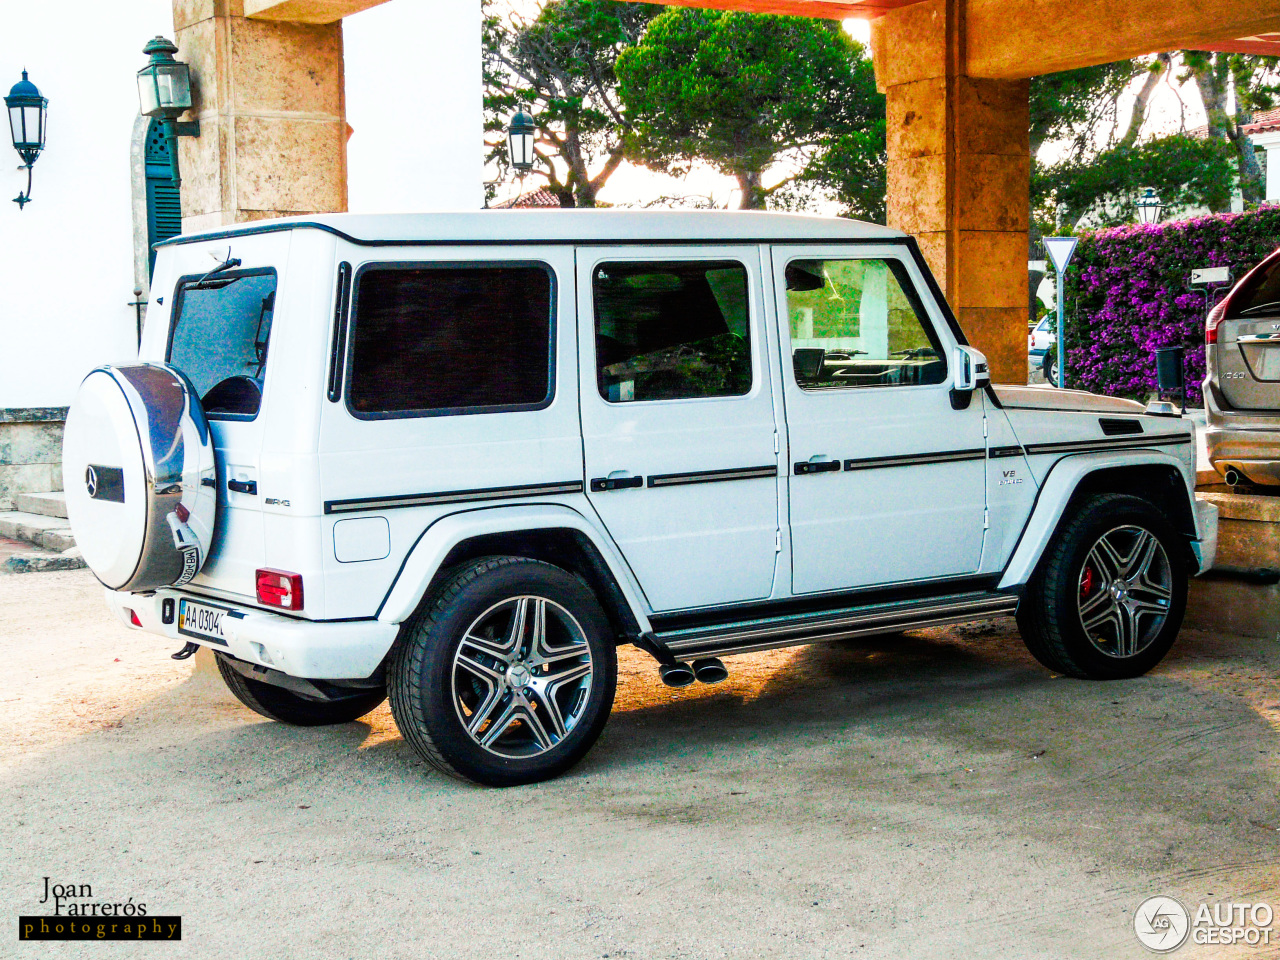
[1215, 259, 1280, 410]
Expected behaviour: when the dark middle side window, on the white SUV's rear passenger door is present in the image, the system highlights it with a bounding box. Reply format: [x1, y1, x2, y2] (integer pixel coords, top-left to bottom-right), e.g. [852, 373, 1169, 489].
[591, 261, 751, 403]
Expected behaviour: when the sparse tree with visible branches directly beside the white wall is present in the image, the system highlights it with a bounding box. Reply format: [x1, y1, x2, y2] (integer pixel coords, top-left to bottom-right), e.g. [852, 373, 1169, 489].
[484, 0, 662, 206]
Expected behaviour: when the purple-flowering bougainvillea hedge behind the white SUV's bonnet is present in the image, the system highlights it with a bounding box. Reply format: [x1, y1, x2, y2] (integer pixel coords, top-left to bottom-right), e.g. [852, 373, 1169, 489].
[1065, 206, 1280, 406]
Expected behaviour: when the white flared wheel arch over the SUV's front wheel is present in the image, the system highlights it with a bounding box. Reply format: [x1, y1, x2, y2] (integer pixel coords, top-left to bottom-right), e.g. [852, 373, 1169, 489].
[998, 451, 1197, 589]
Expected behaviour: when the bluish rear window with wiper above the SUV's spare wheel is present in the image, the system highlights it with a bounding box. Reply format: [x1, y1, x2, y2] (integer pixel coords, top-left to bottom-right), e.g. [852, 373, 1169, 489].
[169, 270, 276, 419]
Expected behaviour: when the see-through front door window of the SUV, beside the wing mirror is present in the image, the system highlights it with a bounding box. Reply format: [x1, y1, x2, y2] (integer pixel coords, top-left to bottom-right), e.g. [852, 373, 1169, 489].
[786, 260, 947, 390]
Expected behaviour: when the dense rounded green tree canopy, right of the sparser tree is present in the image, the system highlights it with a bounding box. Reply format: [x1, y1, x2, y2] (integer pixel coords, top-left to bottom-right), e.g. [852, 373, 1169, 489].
[617, 8, 884, 219]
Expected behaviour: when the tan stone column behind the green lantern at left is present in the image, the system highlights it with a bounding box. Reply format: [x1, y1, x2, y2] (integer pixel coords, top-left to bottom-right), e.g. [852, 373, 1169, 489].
[173, 0, 348, 233]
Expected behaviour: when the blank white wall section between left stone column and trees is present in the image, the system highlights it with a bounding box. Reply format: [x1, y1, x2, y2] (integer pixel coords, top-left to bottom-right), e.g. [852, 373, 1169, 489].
[342, 0, 484, 212]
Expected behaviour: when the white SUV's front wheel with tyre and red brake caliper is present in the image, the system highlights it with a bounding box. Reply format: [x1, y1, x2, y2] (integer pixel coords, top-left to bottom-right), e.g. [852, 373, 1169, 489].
[1018, 493, 1187, 680]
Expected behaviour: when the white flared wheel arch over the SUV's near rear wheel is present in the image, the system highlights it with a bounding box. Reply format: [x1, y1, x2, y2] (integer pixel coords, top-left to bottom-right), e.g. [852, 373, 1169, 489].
[378, 504, 650, 636]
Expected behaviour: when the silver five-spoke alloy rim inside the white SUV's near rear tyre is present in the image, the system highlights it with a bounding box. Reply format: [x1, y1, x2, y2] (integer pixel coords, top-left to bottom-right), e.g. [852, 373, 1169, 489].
[451, 596, 593, 759]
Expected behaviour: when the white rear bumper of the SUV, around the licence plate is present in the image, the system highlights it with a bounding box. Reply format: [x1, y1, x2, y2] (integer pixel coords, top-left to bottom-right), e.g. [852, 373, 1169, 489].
[106, 590, 399, 680]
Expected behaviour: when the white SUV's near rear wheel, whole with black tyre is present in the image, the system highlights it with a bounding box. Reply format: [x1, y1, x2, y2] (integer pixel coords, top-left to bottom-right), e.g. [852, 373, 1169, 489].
[388, 557, 617, 786]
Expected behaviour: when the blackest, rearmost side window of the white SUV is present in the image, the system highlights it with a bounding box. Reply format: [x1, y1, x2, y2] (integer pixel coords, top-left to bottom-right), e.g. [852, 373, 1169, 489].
[349, 265, 552, 416]
